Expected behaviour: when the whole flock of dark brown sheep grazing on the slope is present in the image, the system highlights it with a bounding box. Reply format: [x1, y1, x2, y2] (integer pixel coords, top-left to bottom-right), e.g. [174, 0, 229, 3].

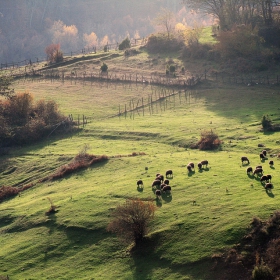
[137, 150, 274, 199]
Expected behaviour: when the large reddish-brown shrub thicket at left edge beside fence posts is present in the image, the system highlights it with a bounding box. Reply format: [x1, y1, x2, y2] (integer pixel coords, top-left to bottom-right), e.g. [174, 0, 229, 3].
[0, 92, 72, 147]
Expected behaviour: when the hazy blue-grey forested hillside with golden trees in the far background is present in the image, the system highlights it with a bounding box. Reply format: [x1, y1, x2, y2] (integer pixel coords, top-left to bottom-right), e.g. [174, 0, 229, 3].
[0, 0, 209, 63]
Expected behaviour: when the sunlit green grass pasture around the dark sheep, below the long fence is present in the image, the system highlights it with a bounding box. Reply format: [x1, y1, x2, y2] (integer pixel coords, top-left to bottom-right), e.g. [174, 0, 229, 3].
[0, 80, 280, 280]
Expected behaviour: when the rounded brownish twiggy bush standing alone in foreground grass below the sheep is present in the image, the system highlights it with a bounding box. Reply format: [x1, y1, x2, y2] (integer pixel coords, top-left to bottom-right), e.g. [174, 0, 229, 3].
[107, 198, 156, 245]
